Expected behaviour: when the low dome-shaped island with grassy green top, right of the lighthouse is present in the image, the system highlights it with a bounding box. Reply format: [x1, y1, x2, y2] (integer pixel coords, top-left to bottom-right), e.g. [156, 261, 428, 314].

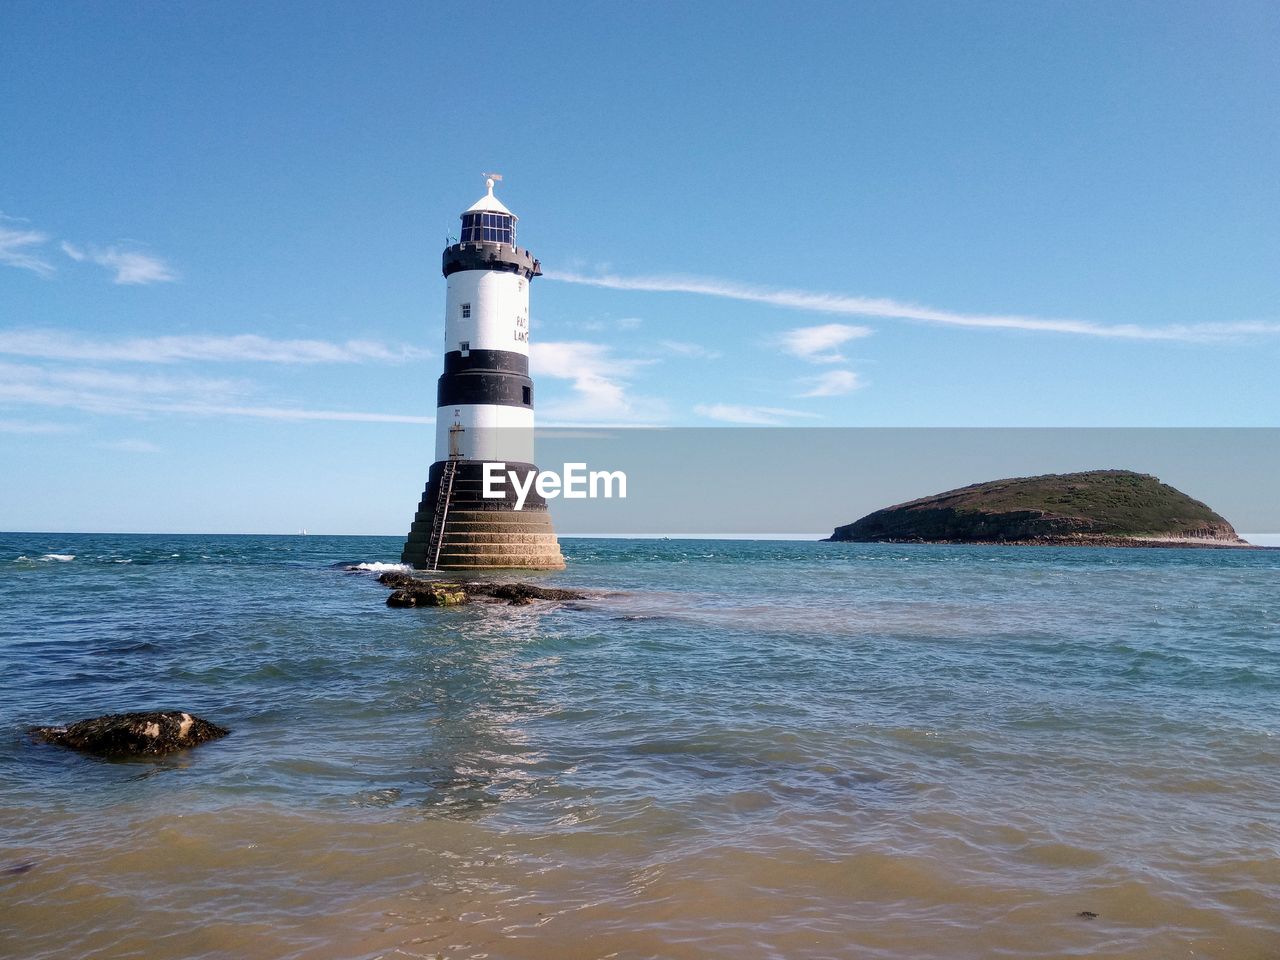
[828, 470, 1249, 547]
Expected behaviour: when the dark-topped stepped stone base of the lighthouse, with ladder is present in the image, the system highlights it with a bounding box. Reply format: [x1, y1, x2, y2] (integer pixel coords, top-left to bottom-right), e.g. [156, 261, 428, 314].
[401, 460, 564, 570]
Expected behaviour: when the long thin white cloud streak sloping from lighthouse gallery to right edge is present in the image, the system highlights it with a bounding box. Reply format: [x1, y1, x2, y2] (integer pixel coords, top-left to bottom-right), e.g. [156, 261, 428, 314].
[547, 273, 1280, 343]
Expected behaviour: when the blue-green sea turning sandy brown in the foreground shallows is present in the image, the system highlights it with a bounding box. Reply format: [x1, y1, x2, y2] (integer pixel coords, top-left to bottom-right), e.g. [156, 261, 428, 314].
[0, 534, 1280, 960]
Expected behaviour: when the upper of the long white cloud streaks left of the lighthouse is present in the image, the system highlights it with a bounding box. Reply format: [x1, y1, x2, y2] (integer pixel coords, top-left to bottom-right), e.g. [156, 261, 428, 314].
[0, 330, 430, 364]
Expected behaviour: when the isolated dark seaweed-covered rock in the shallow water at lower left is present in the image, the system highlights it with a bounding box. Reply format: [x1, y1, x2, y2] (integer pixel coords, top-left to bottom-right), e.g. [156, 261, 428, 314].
[29, 710, 230, 756]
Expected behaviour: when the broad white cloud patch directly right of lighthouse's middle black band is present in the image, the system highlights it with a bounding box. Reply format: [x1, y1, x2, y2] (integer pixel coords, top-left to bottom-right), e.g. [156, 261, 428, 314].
[529, 340, 666, 421]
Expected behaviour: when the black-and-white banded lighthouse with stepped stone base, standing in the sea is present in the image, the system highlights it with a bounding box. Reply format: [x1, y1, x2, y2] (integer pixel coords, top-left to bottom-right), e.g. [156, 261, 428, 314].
[401, 174, 564, 570]
